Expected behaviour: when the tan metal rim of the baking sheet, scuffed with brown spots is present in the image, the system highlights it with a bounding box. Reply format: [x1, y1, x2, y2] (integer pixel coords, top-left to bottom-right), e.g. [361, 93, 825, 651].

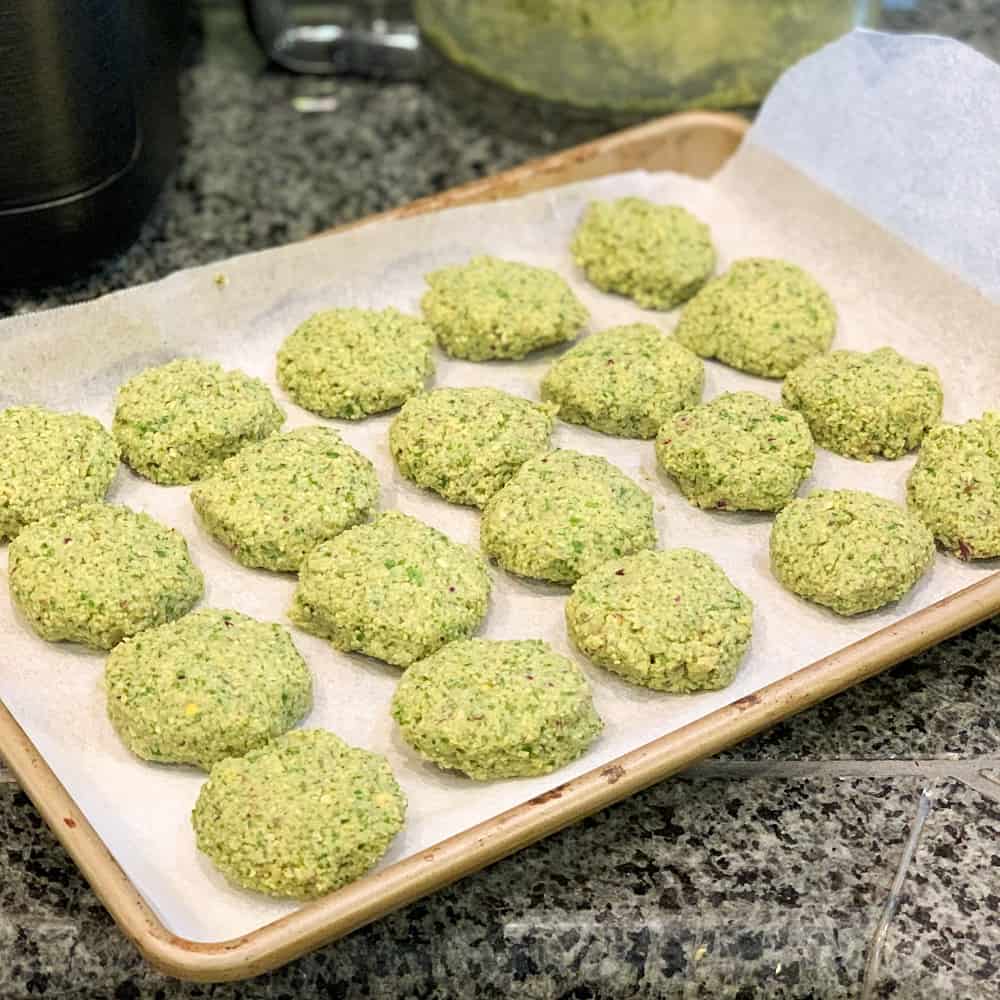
[0, 113, 1000, 982]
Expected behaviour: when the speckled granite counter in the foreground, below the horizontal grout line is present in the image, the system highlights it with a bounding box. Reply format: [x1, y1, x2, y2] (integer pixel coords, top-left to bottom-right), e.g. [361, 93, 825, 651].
[0, 773, 1000, 1000]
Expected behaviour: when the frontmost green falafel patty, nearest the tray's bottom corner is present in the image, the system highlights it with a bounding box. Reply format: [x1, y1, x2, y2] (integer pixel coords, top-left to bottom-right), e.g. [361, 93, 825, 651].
[191, 729, 406, 899]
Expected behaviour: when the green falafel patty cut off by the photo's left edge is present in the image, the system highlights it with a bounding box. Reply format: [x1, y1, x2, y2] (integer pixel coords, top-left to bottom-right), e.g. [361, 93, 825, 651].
[0, 406, 118, 542]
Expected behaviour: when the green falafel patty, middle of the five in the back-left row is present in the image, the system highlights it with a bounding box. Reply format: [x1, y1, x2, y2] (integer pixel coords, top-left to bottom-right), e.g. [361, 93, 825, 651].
[278, 309, 434, 420]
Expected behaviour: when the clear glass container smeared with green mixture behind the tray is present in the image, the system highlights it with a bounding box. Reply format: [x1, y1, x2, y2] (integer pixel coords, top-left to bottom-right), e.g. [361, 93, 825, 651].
[414, 0, 880, 114]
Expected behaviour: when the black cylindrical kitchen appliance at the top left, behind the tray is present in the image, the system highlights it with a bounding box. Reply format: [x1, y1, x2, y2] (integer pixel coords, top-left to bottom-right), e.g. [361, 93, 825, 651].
[0, 0, 187, 286]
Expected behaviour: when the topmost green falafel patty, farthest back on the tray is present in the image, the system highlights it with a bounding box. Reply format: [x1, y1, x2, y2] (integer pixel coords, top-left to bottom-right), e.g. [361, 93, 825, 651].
[570, 197, 715, 309]
